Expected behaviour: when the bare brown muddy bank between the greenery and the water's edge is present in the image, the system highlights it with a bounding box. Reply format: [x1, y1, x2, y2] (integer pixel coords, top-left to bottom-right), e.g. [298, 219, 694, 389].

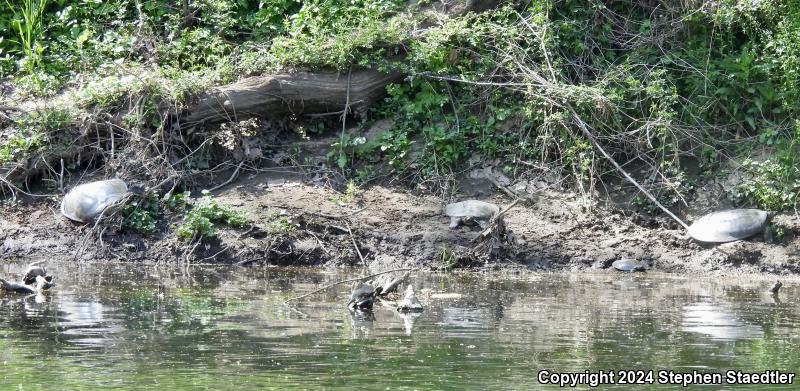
[0, 170, 800, 275]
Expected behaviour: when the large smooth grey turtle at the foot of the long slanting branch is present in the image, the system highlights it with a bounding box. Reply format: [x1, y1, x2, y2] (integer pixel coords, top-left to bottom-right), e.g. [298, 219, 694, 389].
[689, 209, 770, 243]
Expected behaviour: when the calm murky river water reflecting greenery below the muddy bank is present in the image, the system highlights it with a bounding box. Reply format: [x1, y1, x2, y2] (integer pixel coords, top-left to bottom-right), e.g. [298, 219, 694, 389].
[0, 261, 800, 390]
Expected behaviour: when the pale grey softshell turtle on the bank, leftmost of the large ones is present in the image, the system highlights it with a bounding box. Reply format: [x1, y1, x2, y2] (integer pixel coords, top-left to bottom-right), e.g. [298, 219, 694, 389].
[61, 179, 128, 223]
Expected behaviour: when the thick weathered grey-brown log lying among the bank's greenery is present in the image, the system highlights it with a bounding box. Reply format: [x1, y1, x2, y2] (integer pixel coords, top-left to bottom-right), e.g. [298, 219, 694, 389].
[182, 70, 402, 126]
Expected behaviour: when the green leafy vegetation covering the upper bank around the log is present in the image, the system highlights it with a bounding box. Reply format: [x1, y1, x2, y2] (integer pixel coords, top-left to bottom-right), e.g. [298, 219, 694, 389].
[0, 0, 800, 214]
